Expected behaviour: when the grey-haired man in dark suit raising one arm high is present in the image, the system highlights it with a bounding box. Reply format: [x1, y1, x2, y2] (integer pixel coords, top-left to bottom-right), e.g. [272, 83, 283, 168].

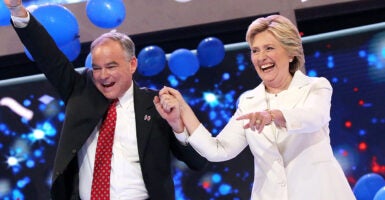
[4, 0, 207, 200]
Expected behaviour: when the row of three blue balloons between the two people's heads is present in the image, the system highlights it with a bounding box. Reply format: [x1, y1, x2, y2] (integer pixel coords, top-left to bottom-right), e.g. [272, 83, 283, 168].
[138, 37, 225, 77]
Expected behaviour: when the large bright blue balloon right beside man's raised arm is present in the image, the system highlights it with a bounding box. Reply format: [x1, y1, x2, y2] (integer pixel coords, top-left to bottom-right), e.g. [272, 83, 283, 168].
[32, 4, 79, 45]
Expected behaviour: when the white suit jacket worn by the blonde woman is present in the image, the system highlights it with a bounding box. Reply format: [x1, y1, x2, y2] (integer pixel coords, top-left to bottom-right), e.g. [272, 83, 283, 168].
[188, 71, 355, 200]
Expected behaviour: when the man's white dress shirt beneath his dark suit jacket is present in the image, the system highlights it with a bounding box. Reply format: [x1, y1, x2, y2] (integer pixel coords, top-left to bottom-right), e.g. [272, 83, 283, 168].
[78, 85, 149, 199]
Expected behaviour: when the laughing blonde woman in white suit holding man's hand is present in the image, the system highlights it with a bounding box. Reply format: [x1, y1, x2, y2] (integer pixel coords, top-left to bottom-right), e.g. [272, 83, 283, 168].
[154, 15, 355, 200]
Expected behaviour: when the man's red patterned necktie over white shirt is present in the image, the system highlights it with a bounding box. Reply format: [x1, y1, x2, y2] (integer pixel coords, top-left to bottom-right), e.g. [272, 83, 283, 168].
[91, 100, 117, 200]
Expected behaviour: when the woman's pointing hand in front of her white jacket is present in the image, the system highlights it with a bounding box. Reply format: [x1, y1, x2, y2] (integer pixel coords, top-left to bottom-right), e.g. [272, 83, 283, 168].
[237, 110, 274, 133]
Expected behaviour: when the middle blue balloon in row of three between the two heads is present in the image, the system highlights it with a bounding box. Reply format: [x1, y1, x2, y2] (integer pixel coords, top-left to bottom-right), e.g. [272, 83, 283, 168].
[168, 49, 199, 77]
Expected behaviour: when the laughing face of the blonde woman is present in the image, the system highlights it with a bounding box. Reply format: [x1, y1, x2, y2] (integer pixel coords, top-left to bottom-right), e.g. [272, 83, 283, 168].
[250, 31, 293, 88]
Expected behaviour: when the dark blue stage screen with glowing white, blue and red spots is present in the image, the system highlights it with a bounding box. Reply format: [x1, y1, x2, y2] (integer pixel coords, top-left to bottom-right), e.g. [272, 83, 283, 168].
[0, 21, 385, 200]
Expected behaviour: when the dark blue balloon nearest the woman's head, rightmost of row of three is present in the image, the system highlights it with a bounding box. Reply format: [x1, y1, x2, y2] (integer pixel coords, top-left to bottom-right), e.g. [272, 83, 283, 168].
[197, 37, 225, 67]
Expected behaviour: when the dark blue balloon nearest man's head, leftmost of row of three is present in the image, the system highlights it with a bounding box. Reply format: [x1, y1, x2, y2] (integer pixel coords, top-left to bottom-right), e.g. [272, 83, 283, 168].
[138, 45, 166, 76]
